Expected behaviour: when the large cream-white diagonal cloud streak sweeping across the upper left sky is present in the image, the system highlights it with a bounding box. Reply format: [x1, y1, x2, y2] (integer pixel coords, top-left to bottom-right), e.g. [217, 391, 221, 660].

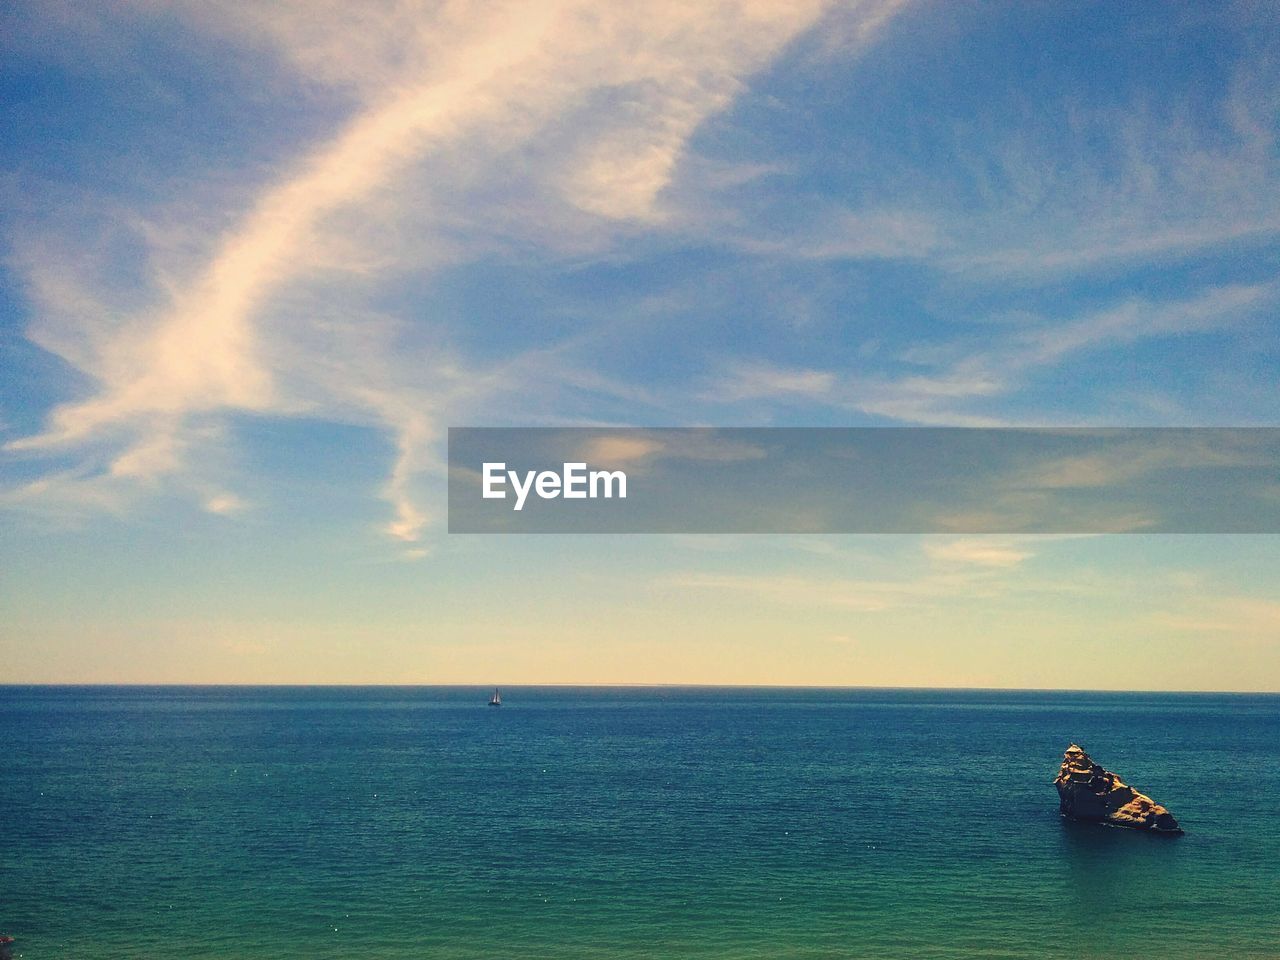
[9, 0, 916, 541]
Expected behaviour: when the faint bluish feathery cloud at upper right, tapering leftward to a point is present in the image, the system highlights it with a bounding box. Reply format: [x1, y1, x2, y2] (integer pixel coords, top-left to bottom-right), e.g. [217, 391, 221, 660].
[733, 26, 1280, 280]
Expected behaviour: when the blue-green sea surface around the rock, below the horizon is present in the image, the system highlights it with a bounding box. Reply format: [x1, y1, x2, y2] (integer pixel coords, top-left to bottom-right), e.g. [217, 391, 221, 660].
[0, 687, 1280, 960]
